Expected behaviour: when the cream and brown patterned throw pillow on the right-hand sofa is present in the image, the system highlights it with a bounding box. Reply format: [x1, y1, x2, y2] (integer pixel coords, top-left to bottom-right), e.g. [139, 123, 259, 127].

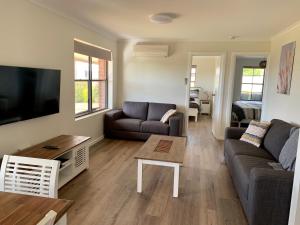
[240, 120, 271, 147]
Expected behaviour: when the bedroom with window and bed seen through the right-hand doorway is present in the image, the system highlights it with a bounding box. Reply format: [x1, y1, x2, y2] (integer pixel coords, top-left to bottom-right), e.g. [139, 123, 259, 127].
[230, 55, 267, 127]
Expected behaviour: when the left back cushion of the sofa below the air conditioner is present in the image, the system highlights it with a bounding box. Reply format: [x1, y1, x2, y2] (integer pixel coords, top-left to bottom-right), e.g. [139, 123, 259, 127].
[123, 101, 149, 120]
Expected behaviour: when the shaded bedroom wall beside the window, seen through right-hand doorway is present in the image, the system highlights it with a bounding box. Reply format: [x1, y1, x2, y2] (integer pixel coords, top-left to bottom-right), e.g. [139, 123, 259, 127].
[232, 57, 266, 102]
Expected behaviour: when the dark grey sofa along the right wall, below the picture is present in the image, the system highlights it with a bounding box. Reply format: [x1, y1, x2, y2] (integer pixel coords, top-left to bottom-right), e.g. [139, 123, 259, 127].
[224, 119, 294, 225]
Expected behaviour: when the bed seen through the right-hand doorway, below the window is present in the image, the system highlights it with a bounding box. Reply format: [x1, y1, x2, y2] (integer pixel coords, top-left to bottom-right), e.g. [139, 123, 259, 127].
[231, 101, 262, 127]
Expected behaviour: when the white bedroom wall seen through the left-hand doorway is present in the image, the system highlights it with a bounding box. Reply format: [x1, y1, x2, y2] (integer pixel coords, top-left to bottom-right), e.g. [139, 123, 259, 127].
[192, 56, 217, 99]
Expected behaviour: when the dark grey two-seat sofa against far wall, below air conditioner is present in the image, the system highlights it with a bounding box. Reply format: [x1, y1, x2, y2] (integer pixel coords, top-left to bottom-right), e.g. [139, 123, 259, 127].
[104, 101, 184, 140]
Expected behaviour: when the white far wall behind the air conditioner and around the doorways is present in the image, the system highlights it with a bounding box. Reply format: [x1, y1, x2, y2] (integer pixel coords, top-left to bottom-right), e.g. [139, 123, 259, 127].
[118, 41, 270, 137]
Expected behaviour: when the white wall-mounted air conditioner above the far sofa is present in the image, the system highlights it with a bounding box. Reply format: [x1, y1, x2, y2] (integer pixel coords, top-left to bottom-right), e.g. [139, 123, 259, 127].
[134, 44, 169, 57]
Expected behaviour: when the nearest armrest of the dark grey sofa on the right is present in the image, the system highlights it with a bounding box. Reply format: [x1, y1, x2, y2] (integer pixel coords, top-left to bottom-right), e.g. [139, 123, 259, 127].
[248, 168, 294, 225]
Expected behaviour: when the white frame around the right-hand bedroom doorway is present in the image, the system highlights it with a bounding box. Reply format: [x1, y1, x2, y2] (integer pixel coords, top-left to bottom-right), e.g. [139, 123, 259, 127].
[225, 52, 270, 127]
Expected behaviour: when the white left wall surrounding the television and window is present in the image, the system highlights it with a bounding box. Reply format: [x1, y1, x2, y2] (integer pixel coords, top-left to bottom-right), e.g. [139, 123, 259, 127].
[0, 0, 117, 155]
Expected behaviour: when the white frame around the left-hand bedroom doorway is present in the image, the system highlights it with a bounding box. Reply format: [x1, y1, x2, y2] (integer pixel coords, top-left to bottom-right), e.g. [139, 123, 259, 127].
[185, 52, 226, 139]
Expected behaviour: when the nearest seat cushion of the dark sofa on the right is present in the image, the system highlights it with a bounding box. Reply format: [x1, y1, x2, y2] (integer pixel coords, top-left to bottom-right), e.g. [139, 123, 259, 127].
[232, 155, 275, 199]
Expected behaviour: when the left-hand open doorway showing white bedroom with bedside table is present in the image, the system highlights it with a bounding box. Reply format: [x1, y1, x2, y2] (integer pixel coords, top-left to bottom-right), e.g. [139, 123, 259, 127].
[186, 53, 225, 139]
